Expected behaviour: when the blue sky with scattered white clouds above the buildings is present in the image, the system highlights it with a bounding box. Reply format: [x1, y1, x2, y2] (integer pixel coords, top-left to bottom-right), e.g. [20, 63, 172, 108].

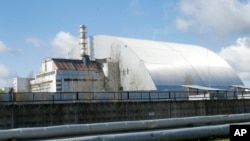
[0, 0, 250, 87]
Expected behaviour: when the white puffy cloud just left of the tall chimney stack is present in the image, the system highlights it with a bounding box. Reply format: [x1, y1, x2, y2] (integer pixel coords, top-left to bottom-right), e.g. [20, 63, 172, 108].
[51, 31, 79, 58]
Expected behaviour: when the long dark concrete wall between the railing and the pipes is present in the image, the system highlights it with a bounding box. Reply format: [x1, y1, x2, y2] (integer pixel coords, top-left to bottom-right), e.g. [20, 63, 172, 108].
[0, 99, 250, 129]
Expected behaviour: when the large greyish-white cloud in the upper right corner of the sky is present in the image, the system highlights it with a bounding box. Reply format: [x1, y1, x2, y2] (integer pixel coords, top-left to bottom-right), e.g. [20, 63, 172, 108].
[175, 0, 250, 34]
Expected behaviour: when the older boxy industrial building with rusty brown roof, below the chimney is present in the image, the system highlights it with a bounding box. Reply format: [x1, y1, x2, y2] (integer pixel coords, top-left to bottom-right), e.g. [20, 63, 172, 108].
[30, 58, 104, 92]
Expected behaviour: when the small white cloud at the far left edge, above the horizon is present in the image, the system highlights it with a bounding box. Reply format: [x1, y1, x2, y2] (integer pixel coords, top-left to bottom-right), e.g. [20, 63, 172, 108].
[0, 64, 14, 87]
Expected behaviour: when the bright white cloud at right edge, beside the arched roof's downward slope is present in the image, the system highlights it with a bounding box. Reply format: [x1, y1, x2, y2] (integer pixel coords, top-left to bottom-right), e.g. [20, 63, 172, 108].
[219, 37, 250, 81]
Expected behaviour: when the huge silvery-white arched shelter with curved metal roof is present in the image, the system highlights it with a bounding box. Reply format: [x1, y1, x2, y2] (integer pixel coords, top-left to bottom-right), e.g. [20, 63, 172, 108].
[69, 35, 243, 90]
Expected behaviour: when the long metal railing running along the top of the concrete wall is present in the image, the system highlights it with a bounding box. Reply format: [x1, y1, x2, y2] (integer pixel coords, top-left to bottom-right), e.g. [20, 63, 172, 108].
[0, 91, 250, 104]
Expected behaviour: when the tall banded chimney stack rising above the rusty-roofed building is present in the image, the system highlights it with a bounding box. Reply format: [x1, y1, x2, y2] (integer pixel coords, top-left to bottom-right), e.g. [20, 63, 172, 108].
[79, 25, 89, 65]
